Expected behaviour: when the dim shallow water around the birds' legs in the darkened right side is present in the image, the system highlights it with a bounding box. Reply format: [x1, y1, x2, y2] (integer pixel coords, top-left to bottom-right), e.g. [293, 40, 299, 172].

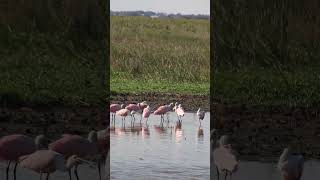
[211, 160, 320, 180]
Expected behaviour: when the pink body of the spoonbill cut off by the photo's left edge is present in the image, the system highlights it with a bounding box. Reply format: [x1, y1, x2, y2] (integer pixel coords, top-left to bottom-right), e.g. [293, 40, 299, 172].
[0, 134, 36, 161]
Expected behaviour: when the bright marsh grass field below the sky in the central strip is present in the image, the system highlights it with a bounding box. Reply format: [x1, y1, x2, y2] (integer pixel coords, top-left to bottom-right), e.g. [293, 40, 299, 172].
[110, 16, 210, 94]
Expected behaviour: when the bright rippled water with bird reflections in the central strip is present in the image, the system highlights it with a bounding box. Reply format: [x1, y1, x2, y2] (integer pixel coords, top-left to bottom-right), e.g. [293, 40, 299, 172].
[110, 113, 210, 180]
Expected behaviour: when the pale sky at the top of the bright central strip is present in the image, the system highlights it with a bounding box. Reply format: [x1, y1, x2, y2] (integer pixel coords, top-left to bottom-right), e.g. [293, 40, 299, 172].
[110, 0, 210, 15]
